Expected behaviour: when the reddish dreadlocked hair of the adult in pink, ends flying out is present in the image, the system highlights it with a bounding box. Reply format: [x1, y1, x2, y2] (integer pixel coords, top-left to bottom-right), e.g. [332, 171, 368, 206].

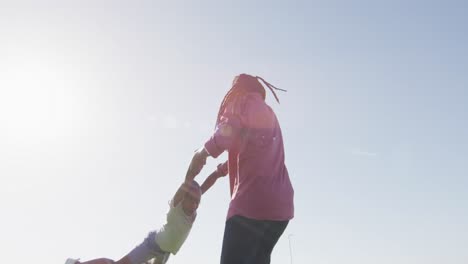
[216, 73, 286, 125]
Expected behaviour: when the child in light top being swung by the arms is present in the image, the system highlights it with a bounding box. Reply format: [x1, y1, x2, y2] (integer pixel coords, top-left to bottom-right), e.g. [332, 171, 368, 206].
[65, 169, 222, 264]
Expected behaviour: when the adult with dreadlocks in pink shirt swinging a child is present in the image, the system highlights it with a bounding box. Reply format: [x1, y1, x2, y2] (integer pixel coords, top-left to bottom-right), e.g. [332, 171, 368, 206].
[189, 74, 294, 264]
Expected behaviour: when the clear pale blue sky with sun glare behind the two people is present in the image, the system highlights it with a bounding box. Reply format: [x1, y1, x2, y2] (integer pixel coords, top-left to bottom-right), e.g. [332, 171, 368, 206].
[0, 1, 468, 264]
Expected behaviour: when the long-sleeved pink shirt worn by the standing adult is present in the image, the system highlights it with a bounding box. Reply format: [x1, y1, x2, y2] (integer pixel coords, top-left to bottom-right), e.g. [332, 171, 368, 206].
[205, 93, 294, 221]
